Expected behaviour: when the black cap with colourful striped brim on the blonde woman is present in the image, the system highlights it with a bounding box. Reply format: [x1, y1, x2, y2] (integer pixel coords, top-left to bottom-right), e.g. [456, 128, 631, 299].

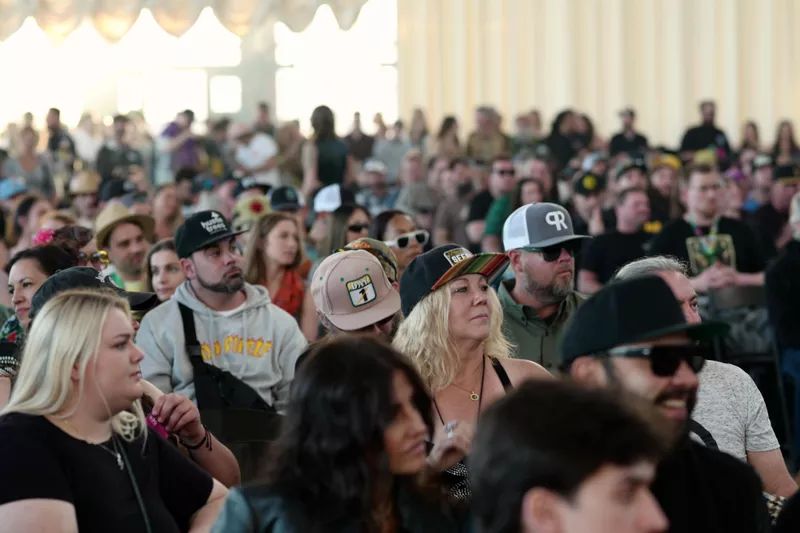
[400, 244, 509, 316]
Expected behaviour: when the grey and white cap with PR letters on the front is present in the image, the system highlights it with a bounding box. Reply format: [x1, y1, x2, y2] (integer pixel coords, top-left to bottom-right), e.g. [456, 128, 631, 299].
[503, 202, 591, 251]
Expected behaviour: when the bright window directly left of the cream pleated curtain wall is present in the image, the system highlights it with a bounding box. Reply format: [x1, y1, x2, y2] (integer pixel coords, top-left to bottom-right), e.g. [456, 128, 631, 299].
[275, 0, 402, 133]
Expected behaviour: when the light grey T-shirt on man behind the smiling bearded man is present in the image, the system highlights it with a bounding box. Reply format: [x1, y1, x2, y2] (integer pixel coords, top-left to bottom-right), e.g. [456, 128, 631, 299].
[691, 361, 780, 461]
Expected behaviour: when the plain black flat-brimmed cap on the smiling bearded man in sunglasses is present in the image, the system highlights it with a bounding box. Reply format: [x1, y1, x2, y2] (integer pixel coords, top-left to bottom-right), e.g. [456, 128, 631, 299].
[559, 276, 730, 367]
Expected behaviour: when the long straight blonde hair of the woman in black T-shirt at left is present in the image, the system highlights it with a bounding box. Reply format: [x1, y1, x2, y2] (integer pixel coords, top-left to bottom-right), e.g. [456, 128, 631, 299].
[2, 289, 146, 441]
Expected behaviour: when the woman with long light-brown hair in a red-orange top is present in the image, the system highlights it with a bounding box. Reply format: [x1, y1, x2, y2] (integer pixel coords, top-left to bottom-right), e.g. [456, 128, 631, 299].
[244, 213, 318, 342]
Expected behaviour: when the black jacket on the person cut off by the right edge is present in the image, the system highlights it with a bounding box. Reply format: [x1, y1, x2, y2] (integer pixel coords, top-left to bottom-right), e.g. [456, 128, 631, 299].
[764, 239, 800, 349]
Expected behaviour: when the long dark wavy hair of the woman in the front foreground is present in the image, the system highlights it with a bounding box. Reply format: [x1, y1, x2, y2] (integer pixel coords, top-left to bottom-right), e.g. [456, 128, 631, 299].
[266, 335, 433, 532]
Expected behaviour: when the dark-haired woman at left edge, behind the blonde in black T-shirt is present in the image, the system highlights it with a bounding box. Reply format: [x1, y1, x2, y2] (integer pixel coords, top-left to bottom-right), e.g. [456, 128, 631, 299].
[0, 244, 78, 344]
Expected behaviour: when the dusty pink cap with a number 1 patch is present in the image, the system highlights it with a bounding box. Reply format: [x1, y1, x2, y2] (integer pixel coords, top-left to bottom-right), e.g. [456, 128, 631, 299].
[311, 250, 400, 331]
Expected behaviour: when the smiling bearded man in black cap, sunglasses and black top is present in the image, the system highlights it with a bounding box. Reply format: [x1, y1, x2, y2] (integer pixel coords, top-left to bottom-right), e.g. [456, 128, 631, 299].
[560, 276, 769, 533]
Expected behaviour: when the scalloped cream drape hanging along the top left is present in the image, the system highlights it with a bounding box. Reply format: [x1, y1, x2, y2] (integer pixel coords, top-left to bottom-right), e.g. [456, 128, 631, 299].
[0, 0, 367, 43]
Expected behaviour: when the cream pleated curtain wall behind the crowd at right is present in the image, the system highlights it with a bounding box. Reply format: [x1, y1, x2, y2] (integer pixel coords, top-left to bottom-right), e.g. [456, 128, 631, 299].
[398, 0, 800, 146]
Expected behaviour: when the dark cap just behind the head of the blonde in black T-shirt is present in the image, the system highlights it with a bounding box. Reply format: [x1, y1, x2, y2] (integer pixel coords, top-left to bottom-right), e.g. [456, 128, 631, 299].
[28, 267, 161, 318]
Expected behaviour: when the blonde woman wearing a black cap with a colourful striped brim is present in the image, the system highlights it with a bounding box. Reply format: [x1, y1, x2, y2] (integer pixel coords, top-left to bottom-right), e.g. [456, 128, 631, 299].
[393, 244, 552, 500]
